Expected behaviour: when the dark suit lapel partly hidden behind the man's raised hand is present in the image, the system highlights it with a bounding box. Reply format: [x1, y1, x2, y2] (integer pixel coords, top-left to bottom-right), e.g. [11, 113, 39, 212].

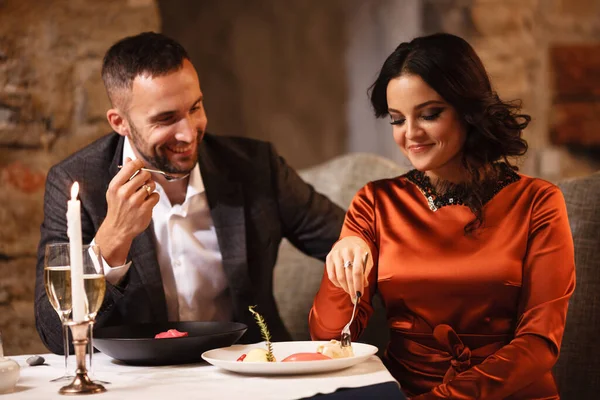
[105, 137, 168, 321]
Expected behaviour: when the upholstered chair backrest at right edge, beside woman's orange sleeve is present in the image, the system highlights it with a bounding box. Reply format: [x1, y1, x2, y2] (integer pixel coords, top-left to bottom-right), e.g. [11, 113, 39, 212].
[554, 172, 600, 400]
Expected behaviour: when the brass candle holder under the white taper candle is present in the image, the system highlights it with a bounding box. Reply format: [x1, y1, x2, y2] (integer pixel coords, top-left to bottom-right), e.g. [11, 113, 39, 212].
[58, 320, 106, 395]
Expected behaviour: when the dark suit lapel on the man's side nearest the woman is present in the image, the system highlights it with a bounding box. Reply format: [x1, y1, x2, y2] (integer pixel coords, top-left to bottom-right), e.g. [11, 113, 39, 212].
[199, 138, 252, 320]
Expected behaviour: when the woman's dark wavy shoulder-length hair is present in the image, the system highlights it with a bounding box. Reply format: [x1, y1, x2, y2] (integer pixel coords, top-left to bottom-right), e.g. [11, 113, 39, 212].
[369, 33, 531, 234]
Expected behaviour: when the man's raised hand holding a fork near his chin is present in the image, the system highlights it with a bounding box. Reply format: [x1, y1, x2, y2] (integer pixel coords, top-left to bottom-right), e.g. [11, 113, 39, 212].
[95, 158, 159, 267]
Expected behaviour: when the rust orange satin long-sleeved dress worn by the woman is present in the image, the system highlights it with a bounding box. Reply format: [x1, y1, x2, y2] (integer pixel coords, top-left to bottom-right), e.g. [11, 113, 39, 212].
[309, 165, 575, 399]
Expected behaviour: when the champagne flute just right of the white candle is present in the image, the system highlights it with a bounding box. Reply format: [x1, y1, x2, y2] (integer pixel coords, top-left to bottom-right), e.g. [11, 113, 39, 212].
[83, 245, 110, 384]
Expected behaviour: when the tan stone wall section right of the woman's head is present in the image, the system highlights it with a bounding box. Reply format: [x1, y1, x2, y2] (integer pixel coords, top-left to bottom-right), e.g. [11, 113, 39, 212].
[424, 0, 600, 181]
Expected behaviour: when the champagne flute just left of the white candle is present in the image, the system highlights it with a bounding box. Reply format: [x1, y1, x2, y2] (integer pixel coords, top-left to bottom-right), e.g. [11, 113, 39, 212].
[44, 243, 74, 382]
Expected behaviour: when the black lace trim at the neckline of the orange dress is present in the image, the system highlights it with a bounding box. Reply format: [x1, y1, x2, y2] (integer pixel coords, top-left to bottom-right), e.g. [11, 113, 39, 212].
[404, 163, 521, 211]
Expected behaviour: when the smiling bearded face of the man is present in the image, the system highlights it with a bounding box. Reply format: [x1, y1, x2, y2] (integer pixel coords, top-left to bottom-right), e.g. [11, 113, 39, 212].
[120, 60, 207, 174]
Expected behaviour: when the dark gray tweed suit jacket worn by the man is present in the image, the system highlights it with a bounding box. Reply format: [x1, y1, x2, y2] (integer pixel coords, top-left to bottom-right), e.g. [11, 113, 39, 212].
[35, 133, 344, 354]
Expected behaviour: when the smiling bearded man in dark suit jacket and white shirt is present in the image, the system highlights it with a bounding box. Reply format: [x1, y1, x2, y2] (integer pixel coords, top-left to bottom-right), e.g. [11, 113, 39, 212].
[35, 33, 344, 353]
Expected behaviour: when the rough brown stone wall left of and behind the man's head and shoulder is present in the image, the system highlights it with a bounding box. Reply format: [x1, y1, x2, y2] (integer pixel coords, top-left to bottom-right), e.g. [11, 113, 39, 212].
[0, 0, 160, 355]
